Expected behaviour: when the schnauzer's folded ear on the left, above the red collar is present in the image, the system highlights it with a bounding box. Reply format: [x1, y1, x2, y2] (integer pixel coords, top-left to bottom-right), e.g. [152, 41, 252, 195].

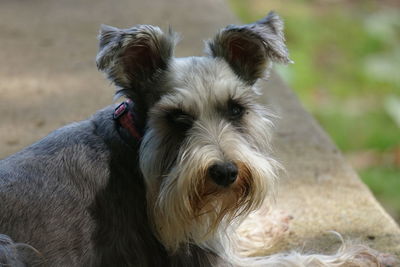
[96, 25, 178, 101]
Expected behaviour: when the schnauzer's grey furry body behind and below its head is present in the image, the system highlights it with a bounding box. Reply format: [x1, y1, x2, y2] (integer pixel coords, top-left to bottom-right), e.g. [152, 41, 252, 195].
[0, 106, 219, 266]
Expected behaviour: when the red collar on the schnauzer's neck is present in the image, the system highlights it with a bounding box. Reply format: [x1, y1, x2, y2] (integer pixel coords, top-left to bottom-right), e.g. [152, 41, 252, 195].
[113, 99, 142, 140]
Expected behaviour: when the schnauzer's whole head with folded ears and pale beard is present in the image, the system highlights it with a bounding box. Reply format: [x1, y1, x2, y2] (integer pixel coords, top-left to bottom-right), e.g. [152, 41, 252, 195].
[97, 13, 290, 251]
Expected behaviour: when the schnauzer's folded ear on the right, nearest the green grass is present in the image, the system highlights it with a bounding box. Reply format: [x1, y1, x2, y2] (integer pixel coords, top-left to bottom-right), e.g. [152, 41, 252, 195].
[206, 12, 291, 85]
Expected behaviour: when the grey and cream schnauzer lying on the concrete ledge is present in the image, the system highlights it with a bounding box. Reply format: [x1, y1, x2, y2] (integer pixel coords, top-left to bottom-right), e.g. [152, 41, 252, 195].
[0, 12, 394, 266]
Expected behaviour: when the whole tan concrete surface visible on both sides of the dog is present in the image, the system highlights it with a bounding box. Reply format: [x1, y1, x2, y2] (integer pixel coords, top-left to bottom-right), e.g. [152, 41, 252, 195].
[0, 0, 400, 256]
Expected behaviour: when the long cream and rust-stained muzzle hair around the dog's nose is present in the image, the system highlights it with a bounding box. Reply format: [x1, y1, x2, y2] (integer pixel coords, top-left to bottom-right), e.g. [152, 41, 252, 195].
[148, 133, 276, 252]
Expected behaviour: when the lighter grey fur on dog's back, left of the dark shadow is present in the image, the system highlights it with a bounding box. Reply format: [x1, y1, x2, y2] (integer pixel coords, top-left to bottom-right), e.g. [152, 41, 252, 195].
[0, 108, 112, 266]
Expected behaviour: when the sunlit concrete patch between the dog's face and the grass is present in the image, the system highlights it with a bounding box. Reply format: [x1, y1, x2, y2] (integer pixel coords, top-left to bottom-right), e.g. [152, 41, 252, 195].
[263, 76, 400, 256]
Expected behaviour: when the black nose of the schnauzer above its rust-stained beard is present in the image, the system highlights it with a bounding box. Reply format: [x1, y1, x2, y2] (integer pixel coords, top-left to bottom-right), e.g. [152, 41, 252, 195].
[208, 162, 238, 187]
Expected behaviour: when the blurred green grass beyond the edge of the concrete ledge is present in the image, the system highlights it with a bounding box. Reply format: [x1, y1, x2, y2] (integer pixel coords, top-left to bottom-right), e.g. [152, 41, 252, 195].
[230, 0, 400, 222]
